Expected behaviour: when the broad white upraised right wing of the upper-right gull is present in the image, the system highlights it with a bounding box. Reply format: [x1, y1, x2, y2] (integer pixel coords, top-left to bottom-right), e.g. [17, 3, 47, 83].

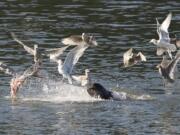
[159, 13, 172, 43]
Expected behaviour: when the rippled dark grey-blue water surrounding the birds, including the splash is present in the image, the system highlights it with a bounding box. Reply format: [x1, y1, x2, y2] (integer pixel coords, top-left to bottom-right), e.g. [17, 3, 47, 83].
[0, 0, 180, 135]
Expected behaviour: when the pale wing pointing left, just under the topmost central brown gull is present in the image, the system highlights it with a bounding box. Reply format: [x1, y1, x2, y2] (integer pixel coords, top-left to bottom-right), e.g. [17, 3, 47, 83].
[46, 46, 69, 61]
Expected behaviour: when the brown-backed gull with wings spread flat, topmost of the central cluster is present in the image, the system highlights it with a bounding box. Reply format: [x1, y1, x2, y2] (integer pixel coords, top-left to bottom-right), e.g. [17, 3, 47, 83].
[61, 33, 98, 46]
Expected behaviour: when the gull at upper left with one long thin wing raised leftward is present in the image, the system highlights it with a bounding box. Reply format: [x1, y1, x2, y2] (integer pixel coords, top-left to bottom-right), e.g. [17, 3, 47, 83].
[10, 32, 42, 63]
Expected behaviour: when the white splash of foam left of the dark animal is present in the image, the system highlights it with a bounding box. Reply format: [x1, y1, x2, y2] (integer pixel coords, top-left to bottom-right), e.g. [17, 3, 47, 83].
[18, 80, 100, 103]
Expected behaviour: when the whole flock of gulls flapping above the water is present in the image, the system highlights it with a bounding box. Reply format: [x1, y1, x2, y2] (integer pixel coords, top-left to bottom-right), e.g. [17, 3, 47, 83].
[0, 13, 180, 99]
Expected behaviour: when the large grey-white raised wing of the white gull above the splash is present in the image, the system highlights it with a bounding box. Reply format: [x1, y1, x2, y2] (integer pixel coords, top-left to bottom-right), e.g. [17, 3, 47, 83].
[63, 45, 88, 74]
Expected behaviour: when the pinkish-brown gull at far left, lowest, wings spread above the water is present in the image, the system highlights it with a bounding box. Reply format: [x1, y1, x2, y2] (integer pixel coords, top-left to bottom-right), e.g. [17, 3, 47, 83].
[0, 45, 40, 99]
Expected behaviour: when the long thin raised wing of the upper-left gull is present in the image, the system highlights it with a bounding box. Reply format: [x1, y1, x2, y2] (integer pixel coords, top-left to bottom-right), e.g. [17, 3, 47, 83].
[11, 32, 35, 55]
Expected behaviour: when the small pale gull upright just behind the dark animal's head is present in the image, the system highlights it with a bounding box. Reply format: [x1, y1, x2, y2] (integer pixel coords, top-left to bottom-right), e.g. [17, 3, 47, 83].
[72, 69, 90, 86]
